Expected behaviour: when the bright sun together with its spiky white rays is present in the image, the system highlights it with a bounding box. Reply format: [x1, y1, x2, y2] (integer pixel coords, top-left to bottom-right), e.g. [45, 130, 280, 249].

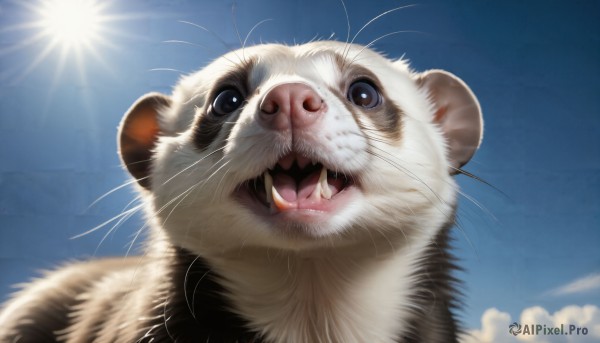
[0, 0, 119, 87]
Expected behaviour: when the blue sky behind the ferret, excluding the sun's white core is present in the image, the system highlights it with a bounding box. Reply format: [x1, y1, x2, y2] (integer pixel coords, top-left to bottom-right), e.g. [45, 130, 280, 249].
[0, 0, 600, 341]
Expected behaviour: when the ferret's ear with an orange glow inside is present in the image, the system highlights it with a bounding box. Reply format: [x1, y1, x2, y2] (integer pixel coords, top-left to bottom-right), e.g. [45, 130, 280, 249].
[118, 93, 171, 189]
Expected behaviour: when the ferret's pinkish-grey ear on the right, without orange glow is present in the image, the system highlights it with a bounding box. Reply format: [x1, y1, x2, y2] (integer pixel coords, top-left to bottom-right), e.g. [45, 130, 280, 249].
[417, 70, 483, 174]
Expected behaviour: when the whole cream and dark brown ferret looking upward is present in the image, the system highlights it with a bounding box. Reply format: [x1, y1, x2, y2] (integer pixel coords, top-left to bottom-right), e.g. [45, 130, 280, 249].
[0, 41, 483, 343]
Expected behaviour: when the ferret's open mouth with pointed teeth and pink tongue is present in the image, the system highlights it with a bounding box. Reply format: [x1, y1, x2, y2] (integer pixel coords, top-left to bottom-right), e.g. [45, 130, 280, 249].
[240, 153, 355, 214]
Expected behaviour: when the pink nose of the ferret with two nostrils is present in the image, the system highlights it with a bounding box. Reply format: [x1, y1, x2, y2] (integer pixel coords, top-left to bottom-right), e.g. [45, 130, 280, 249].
[258, 83, 327, 130]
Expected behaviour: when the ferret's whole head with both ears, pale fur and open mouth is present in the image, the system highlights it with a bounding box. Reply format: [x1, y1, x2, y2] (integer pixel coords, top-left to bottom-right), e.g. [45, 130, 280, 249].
[119, 42, 482, 254]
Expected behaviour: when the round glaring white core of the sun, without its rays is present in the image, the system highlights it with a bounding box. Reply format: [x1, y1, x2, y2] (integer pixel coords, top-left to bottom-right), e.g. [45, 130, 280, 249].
[38, 0, 102, 47]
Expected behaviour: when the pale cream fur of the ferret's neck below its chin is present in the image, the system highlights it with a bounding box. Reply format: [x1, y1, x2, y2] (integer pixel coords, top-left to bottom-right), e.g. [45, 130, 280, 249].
[209, 242, 426, 343]
